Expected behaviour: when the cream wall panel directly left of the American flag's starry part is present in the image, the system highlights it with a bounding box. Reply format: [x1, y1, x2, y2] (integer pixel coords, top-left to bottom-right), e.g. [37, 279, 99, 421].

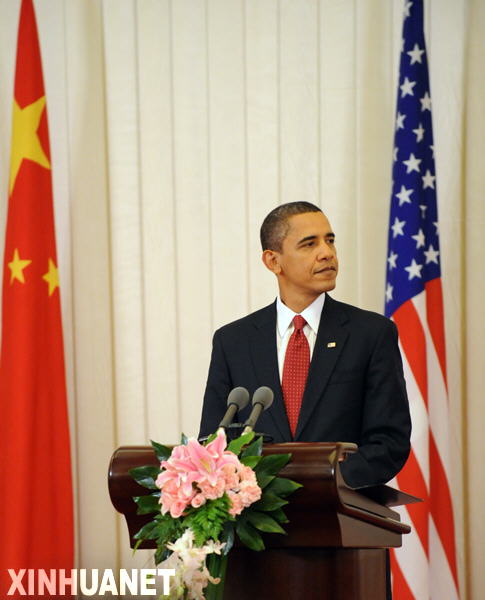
[355, 0, 396, 312]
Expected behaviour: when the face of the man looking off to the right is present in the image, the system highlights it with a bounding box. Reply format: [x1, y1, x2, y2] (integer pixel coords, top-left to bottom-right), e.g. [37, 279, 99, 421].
[268, 212, 338, 305]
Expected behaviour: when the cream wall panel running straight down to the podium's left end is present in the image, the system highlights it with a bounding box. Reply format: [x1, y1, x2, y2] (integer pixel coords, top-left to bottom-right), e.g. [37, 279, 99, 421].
[103, 0, 147, 444]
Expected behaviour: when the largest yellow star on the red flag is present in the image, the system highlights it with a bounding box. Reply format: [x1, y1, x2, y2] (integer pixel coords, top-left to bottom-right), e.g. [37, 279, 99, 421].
[9, 96, 51, 194]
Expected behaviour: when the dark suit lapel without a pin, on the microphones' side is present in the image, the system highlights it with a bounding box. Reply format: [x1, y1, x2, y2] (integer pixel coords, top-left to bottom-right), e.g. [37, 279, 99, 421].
[250, 303, 293, 441]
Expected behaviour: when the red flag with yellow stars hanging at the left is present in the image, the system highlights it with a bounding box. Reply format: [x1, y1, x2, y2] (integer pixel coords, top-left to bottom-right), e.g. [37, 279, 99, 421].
[0, 0, 74, 598]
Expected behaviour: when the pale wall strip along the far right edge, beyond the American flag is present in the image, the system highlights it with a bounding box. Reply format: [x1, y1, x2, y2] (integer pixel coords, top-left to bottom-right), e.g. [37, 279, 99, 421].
[462, 0, 485, 599]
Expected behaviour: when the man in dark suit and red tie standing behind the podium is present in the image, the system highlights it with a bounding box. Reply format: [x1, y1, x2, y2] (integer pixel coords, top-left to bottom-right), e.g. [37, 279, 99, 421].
[200, 202, 411, 487]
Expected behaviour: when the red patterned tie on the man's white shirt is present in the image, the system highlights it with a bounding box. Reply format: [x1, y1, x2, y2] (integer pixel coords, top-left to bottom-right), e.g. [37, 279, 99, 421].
[281, 315, 310, 437]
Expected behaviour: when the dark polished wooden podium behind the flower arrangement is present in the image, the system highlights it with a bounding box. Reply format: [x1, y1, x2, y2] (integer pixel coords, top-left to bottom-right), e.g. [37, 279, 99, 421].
[108, 442, 419, 600]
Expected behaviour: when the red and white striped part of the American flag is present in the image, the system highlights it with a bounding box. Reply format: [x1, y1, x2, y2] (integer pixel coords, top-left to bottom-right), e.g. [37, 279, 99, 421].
[391, 279, 460, 600]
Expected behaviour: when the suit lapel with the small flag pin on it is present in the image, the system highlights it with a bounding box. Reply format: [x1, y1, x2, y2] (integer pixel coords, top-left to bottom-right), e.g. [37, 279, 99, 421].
[295, 294, 349, 440]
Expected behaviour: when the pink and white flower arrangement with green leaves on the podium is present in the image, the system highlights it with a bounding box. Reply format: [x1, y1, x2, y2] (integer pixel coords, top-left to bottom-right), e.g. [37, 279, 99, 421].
[130, 429, 301, 600]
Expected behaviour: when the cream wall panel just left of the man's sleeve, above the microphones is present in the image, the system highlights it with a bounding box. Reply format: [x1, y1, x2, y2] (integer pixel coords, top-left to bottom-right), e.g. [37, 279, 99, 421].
[172, 0, 213, 435]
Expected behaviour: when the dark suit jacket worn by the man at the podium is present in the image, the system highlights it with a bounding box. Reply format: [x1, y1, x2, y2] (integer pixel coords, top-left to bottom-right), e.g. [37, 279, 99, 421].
[200, 294, 411, 487]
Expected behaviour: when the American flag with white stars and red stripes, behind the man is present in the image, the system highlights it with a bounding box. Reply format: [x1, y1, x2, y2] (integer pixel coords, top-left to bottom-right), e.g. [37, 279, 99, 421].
[385, 0, 459, 600]
